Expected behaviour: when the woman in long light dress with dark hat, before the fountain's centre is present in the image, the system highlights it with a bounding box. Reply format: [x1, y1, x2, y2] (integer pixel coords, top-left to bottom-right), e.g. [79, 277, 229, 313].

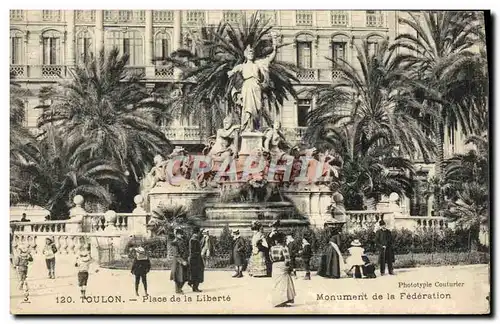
[248, 221, 269, 277]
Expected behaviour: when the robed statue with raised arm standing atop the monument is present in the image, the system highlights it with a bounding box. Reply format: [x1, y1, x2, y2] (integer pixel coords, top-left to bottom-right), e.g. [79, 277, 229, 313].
[227, 35, 277, 131]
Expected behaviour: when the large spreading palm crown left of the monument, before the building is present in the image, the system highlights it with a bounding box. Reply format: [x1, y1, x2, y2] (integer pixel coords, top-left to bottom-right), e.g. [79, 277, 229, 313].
[35, 48, 170, 181]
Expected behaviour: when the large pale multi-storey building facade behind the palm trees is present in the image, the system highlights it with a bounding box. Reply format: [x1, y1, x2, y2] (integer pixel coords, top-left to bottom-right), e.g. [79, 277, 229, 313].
[10, 10, 470, 214]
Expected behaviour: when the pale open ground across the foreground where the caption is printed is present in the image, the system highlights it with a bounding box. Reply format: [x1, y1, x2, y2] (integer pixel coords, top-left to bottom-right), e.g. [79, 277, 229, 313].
[10, 260, 490, 314]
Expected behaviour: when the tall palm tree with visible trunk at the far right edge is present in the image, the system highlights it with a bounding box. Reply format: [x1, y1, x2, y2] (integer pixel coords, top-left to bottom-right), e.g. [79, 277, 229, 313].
[391, 11, 487, 177]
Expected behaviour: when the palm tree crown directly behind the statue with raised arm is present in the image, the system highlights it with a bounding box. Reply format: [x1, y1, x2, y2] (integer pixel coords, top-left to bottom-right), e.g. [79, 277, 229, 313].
[164, 14, 298, 134]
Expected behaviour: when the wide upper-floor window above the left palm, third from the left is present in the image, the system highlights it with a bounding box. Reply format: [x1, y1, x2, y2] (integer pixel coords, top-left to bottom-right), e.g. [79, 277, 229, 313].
[106, 30, 144, 66]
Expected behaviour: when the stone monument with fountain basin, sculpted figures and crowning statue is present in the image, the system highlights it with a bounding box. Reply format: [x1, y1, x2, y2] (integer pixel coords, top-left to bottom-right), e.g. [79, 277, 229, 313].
[143, 34, 338, 235]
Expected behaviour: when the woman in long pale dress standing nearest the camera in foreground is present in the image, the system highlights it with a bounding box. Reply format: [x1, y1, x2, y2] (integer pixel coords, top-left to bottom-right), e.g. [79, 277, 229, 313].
[270, 233, 296, 307]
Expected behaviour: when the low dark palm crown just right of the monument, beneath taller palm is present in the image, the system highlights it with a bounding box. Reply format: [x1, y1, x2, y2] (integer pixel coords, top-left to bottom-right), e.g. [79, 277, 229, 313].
[322, 118, 413, 210]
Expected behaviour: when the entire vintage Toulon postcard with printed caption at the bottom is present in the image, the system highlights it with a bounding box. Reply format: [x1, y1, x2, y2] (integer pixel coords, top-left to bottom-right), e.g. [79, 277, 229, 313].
[9, 9, 491, 315]
